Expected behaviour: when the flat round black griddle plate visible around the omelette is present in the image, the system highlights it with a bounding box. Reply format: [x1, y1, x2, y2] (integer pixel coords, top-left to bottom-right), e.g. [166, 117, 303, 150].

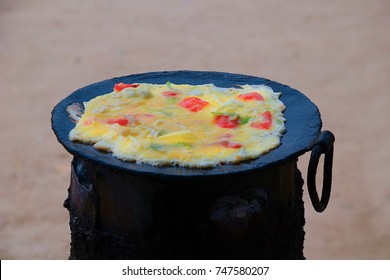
[52, 71, 322, 176]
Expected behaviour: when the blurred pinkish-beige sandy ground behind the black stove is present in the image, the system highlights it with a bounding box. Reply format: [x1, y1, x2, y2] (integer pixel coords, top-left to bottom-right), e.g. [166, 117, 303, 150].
[0, 0, 390, 259]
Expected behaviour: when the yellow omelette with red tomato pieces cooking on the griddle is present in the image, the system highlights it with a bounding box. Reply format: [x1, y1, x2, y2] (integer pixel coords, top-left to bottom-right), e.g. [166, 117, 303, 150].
[69, 82, 285, 168]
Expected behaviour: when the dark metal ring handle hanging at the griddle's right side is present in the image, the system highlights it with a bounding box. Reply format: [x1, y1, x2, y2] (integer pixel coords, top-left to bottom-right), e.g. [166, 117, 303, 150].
[307, 130, 335, 212]
